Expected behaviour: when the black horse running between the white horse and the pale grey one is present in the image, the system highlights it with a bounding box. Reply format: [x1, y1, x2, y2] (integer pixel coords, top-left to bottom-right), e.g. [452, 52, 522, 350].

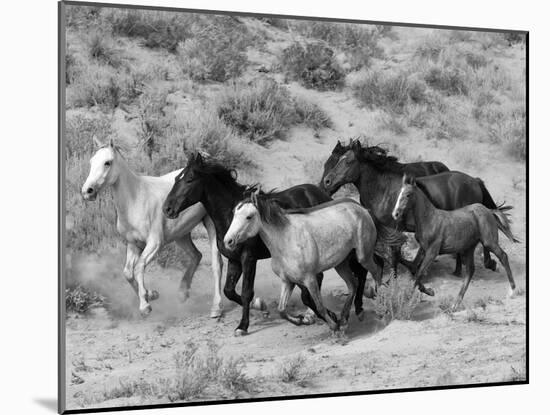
[163, 154, 380, 335]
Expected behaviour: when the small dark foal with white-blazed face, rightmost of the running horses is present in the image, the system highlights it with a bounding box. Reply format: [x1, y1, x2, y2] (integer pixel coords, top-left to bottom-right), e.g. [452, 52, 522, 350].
[392, 174, 519, 310]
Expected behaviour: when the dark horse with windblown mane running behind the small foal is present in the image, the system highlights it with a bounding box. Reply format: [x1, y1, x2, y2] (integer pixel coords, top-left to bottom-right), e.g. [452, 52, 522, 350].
[321, 140, 497, 295]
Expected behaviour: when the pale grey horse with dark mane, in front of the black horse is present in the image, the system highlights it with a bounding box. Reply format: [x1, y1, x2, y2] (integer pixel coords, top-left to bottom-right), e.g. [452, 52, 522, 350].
[224, 190, 382, 331]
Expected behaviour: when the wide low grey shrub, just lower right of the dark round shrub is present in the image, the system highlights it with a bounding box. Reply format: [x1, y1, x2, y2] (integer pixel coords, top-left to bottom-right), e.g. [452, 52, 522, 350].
[352, 71, 428, 113]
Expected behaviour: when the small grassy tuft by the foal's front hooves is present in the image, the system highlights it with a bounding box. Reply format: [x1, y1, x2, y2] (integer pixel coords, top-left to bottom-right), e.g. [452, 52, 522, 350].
[374, 278, 421, 320]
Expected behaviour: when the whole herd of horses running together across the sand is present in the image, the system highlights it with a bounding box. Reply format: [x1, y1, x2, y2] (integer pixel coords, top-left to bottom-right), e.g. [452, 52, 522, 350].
[82, 137, 518, 335]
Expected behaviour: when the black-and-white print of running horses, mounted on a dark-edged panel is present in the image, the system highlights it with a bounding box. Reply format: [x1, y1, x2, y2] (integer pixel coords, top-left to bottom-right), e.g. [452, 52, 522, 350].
[59, 1, 529, 413]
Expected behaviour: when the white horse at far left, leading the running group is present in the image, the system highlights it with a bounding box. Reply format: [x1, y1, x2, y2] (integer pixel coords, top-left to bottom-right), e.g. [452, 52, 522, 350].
[82, 137, 223, 317]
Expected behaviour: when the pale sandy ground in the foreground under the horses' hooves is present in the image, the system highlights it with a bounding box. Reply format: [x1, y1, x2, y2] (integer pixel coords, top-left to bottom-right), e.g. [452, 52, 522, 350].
[67, 234, 526, 409]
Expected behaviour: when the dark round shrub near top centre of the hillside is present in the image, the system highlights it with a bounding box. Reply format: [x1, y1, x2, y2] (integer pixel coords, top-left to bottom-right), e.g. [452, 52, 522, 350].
[281, 42, 344, 91]
